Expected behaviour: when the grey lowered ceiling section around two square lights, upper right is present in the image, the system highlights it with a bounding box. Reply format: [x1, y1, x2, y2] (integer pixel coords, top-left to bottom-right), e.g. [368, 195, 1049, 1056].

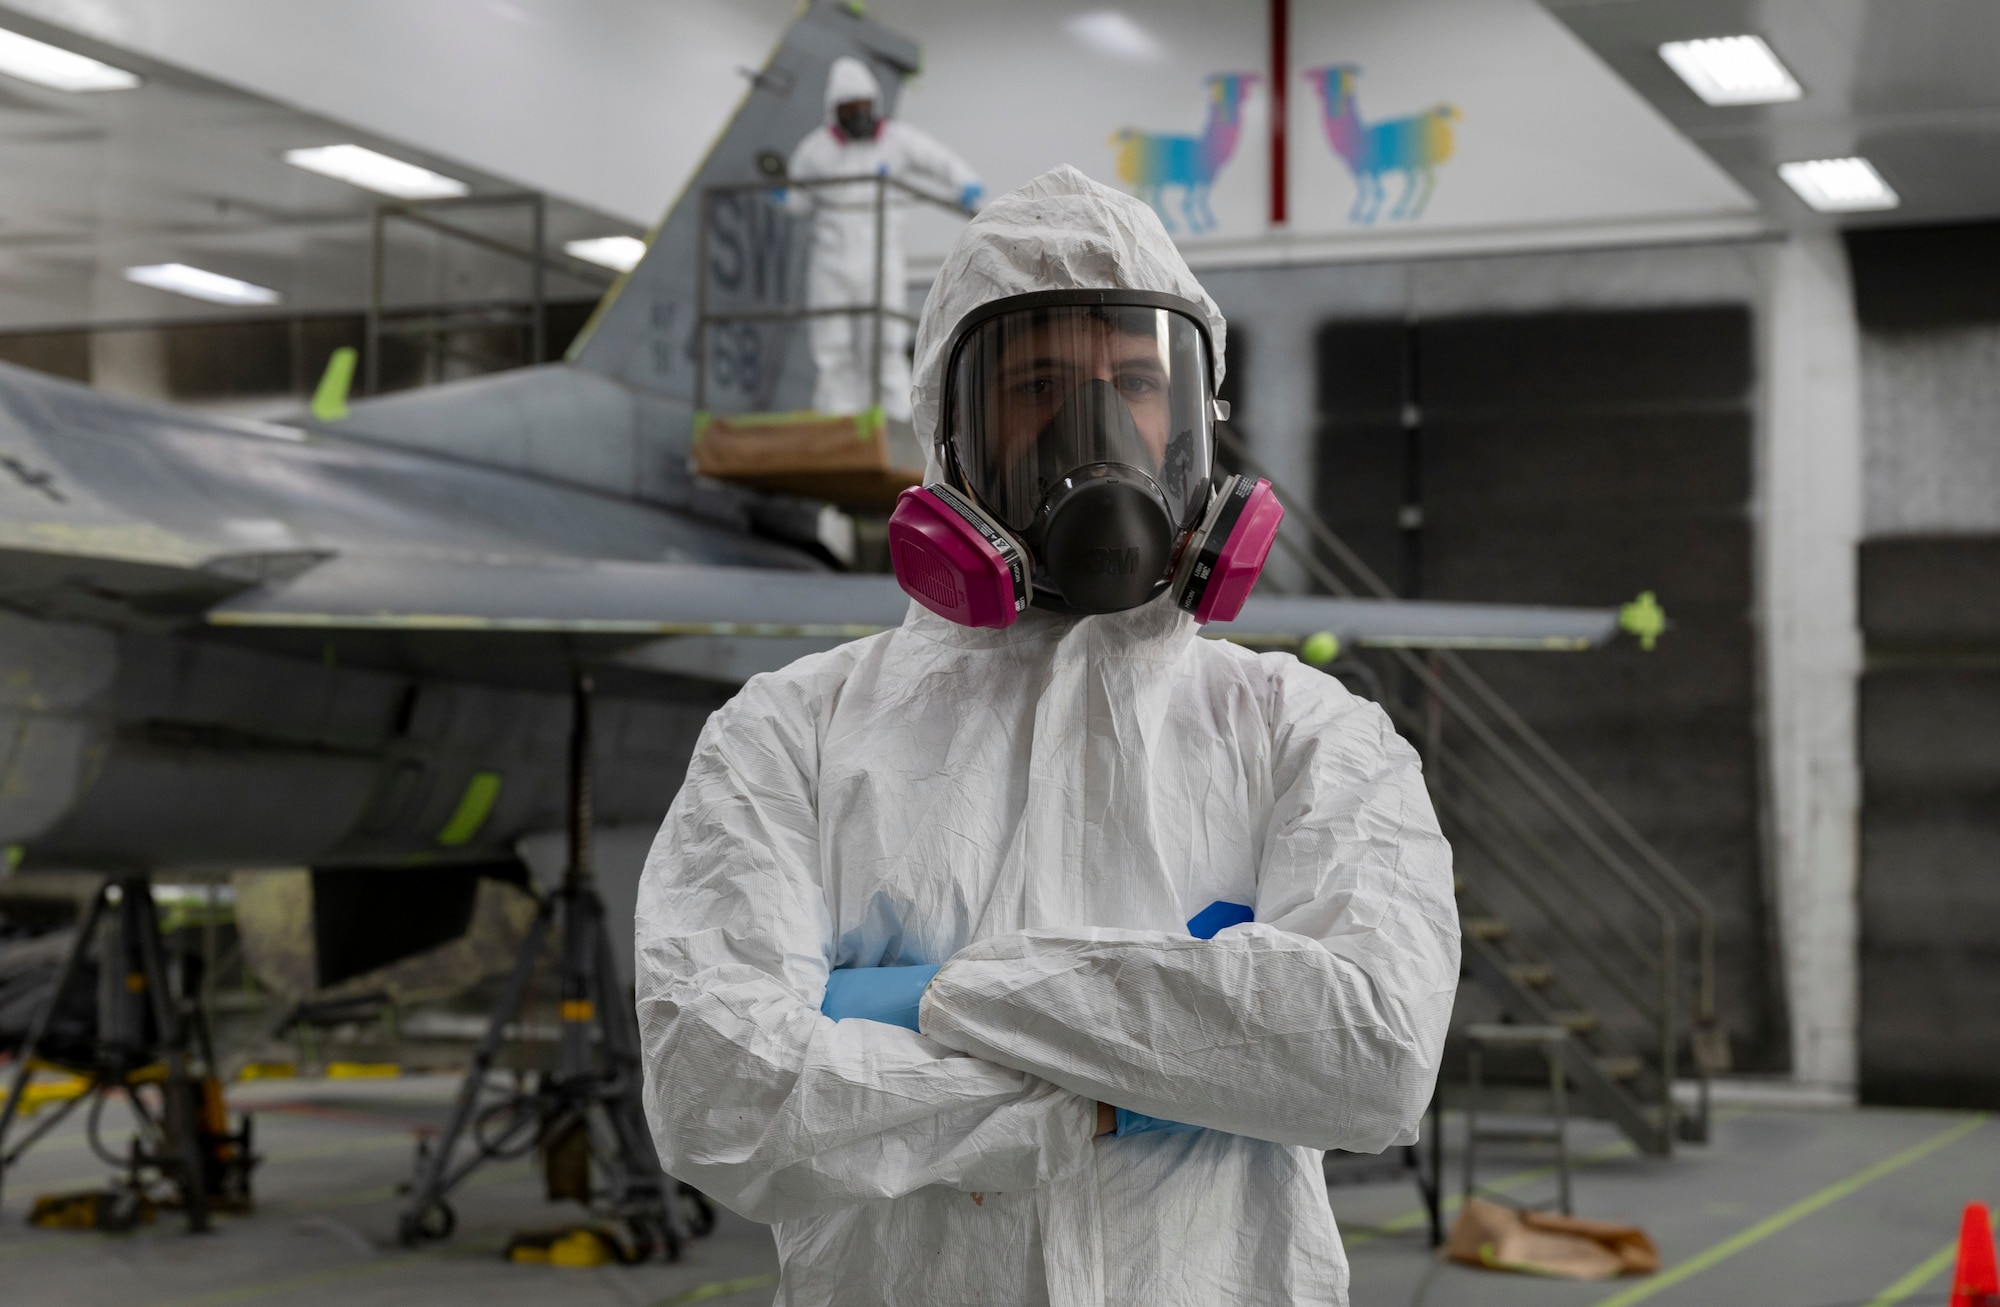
[1544, 0, 2000, 226]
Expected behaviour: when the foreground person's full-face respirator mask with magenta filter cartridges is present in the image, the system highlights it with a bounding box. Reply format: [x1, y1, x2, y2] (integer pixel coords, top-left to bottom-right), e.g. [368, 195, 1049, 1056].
[888, 290, 1284, 628]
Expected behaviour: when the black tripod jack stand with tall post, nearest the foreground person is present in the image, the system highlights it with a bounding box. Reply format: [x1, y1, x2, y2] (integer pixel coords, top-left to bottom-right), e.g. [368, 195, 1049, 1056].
[396, 675, 716, 1261]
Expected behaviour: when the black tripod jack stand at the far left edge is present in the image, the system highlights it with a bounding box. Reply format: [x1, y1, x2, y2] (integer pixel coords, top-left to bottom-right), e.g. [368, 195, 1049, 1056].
[0, 875, 258, 1233]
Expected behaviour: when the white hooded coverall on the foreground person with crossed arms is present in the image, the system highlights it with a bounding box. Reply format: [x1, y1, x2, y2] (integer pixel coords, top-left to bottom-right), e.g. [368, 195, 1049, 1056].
[638, 168, 1458, 1307]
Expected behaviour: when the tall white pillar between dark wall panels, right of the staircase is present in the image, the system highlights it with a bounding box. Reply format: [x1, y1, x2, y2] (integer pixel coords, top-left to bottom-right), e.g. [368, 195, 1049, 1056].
[1758, 234, 1862, 1091]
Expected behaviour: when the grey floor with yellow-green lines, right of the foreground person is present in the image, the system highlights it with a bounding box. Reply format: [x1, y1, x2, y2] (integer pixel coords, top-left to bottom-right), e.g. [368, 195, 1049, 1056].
[1332, 1107, 2000, 1307]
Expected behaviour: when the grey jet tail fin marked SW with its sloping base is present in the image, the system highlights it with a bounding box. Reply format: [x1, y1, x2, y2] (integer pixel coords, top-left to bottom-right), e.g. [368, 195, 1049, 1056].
[326, 0, 920, 522]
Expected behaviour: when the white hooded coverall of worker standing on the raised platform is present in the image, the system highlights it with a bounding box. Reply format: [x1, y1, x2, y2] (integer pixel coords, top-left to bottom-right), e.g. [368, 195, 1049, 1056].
[786, 56, 978, 422]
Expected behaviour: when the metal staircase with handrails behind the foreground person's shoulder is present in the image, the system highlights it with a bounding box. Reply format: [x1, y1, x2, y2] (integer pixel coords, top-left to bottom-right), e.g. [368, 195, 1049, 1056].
[1218, 426, 1728, 1155]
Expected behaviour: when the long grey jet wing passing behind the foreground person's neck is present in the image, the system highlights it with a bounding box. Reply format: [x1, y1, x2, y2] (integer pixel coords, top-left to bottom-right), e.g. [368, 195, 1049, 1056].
[206, 556, 1618, 681]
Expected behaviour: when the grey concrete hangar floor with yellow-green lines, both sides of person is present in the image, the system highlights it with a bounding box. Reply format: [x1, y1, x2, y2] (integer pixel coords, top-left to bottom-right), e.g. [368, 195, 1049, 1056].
[0, 1077, 2000, 1307]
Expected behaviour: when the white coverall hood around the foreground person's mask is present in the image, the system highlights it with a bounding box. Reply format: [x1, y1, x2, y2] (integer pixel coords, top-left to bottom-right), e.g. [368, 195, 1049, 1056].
[916, 163, 1228, 467]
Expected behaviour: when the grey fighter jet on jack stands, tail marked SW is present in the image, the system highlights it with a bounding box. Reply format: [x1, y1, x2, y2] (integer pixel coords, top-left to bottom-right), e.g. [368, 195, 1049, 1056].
[0, 2, 1618, 887]
